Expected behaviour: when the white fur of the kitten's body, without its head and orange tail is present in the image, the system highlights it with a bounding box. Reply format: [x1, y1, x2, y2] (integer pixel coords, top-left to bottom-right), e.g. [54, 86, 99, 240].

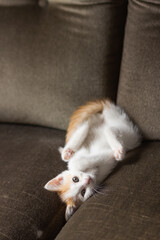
[61, 103, 141, 193]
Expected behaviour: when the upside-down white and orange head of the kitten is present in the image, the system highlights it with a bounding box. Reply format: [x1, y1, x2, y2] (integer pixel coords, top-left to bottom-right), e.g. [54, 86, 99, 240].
[44, 170, 94, 220]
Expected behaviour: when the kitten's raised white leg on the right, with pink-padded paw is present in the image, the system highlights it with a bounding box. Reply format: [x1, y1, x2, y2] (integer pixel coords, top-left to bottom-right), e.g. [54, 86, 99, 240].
[105, 127, 125, 161]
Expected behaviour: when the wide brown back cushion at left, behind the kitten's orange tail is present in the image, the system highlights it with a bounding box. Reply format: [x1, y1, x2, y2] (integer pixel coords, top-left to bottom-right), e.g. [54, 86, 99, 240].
[0, 0, 126, 129]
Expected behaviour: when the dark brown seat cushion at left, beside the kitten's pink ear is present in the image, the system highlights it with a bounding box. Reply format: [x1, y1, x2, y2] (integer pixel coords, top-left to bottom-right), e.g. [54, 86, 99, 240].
[0, 124, 65, 240]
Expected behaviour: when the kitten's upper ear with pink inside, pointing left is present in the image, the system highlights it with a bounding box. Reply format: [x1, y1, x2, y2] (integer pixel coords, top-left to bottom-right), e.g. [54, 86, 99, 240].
[44, 174, 63, 192]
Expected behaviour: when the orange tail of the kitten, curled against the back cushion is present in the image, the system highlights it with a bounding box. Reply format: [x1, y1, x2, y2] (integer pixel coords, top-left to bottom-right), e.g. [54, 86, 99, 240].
[66, 99, 110, 143]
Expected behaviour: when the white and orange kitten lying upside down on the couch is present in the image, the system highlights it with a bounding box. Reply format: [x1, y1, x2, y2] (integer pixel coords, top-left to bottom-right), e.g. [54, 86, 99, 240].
[45, 100, 141, 220]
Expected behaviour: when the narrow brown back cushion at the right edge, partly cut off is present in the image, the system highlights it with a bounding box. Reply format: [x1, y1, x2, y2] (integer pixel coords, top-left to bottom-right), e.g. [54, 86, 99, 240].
[118, 0, 160, 139]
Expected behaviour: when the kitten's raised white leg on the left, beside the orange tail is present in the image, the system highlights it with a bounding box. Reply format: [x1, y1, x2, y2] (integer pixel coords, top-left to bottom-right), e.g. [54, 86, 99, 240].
[61, 121, 89, 161]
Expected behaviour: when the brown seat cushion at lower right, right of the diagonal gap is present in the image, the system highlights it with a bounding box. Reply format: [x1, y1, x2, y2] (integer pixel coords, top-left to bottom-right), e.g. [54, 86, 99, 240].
[56, 142, 160, 240]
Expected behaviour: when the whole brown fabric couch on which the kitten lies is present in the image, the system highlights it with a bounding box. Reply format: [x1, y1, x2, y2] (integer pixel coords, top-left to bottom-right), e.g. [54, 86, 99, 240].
[0, 0, 160, 240]
